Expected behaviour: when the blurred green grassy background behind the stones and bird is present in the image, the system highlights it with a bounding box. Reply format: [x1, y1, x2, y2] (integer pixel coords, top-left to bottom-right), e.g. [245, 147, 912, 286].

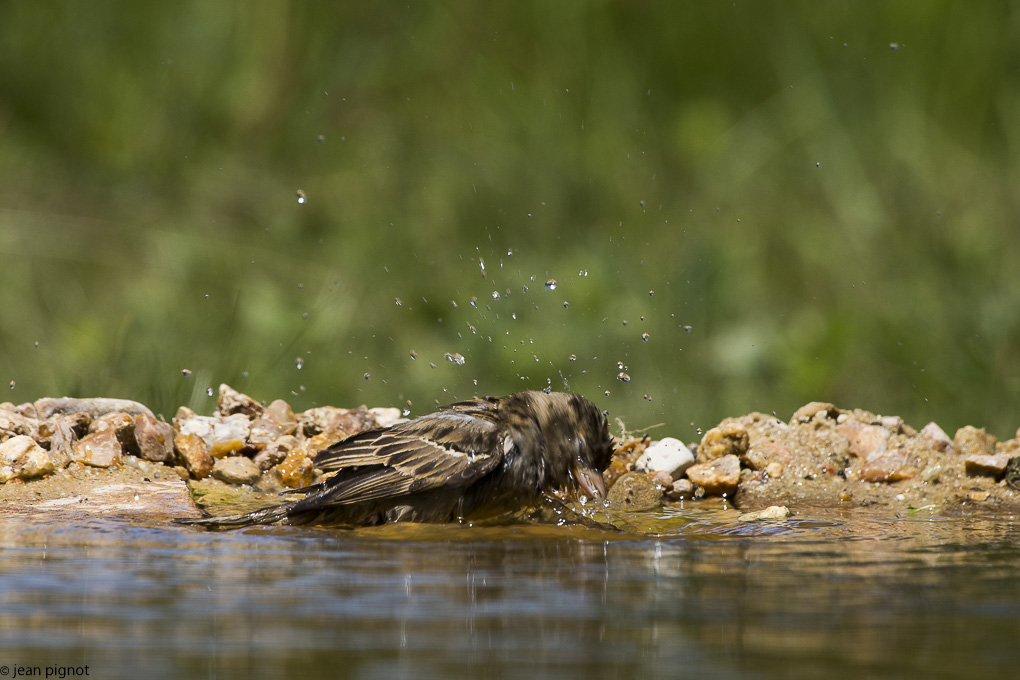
[0, 0, 1020, 439]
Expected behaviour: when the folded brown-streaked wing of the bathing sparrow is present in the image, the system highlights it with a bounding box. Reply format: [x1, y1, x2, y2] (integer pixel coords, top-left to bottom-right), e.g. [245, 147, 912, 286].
[306, 409, 511, 505]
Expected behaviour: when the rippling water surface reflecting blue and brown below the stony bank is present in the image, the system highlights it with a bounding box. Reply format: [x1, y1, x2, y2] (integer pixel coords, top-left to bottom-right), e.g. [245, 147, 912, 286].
[0, 509, 1020, 680]
